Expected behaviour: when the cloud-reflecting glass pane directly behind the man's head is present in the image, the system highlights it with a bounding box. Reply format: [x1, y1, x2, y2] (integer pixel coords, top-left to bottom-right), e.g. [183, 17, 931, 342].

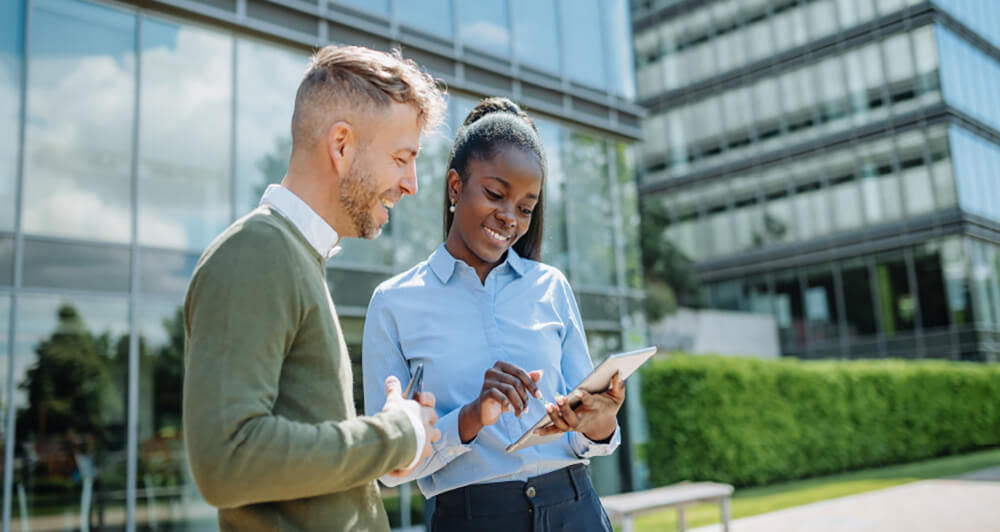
[236, 39, 309, 218]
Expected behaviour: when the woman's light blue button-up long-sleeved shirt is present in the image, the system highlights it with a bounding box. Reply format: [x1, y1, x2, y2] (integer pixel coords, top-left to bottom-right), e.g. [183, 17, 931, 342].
[362, 245, 621, 497]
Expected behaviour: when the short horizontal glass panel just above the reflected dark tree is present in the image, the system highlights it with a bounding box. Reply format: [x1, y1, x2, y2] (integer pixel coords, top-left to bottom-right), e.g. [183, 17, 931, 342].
[23, 238, 131, 292]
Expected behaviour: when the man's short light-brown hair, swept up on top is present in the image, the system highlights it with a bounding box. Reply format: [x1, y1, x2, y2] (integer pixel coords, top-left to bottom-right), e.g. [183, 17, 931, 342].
[292, 46, 445, 149]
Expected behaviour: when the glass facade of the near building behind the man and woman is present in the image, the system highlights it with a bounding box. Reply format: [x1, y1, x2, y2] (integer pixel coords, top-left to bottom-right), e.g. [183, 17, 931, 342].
[0, 0, 645, 531]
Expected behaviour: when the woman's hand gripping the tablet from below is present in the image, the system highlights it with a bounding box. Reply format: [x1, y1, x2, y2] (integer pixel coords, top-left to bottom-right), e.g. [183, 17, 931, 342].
[535, 373, 625, 441]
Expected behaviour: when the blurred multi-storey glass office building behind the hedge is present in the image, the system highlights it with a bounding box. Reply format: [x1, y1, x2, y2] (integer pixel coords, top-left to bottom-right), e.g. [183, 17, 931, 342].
[632, 0, 1000, 360]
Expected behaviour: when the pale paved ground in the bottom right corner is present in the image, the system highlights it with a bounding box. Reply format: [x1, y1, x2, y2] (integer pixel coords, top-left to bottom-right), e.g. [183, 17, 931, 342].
[695, 467, 1000, 532]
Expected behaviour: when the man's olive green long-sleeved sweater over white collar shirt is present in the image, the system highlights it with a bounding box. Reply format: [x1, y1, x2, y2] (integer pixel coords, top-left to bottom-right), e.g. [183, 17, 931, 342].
[184, 207, 416, 531]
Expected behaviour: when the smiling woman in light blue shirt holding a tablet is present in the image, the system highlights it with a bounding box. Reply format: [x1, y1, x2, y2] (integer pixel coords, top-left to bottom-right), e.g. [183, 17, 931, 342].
[362, 98, 625, 532]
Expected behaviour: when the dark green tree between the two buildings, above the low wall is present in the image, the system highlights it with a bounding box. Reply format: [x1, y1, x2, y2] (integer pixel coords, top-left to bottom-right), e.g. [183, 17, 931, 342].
[639, 201, 705, 321]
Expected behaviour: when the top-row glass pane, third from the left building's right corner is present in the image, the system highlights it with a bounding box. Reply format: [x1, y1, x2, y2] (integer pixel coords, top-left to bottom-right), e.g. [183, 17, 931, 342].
[511, 0, 559, 74]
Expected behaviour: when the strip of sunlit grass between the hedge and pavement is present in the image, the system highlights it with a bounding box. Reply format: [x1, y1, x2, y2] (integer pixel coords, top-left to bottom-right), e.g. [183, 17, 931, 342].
[635, 448, 1000, 532]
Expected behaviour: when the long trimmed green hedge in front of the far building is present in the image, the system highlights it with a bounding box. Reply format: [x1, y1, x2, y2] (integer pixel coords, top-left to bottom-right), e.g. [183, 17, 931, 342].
[642, 355, 1000, 486]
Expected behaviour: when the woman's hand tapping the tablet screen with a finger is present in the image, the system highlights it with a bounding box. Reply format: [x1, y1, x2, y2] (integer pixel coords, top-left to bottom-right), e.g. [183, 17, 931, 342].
[458, 361, 542, 443]
